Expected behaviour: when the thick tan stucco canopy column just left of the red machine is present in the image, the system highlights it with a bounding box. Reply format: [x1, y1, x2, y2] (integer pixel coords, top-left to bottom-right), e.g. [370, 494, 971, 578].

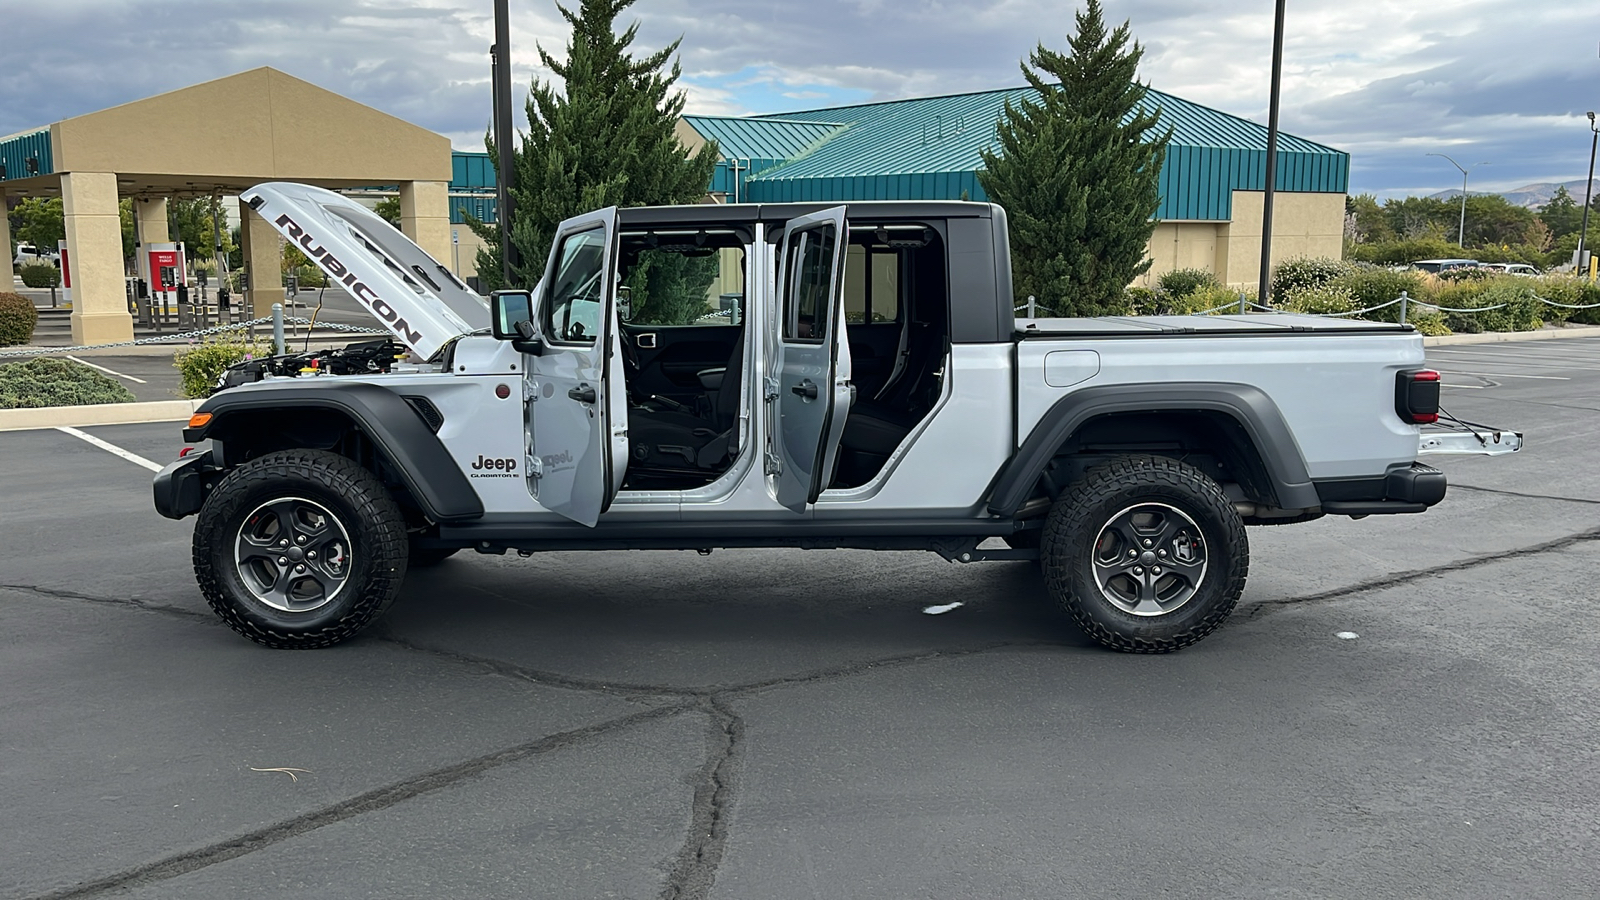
[61, 171, 133, 344]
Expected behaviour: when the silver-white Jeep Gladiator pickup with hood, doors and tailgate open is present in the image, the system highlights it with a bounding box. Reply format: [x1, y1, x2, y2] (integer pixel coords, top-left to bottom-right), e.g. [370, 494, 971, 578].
[155, 184, 1522, 652]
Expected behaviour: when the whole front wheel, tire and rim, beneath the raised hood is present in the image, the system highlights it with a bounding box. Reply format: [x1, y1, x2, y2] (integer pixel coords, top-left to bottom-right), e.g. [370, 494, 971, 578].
[194, 450, 408, 649]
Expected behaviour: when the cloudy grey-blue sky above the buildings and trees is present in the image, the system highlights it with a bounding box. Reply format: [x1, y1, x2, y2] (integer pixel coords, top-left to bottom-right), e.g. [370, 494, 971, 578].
[0, 0, 1600, 197]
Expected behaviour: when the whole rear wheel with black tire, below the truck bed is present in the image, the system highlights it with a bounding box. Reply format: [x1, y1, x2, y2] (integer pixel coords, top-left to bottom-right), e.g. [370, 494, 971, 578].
[1040, 456, 1250, 653]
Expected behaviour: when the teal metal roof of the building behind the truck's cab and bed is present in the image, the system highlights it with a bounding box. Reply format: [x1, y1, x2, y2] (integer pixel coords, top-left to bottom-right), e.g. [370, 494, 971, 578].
[726, 88, 1350, 221]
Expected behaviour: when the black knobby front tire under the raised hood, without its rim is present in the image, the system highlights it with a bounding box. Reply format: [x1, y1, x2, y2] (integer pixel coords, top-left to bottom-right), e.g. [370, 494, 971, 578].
[194, 450, 408, 650]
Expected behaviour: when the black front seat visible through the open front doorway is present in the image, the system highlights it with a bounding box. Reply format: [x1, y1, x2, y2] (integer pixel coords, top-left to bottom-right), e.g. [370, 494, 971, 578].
[627, 333, 746, 471]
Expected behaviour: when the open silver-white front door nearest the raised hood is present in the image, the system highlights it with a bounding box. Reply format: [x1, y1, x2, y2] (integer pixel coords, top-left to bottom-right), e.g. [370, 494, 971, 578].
[523, 207, 627, 525]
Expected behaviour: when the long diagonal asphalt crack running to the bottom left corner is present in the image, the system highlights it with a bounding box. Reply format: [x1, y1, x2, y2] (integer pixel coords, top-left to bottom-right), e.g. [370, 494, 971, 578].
[34, 703, 694, 900]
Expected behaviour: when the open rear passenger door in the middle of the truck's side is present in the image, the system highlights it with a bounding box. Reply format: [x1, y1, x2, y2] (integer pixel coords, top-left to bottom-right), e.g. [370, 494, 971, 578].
[766, 207, 854, 512]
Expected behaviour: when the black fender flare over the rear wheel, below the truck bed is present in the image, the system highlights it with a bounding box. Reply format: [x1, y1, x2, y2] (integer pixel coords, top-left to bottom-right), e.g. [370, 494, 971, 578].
[989, 381, 1322, 517]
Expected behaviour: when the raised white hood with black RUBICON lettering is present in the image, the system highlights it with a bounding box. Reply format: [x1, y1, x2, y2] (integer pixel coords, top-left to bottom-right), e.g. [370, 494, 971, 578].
[240, 181, 490, 359]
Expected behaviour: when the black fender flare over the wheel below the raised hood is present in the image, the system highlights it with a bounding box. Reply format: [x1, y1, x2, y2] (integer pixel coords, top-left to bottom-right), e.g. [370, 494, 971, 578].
[184, 381, 483, 522]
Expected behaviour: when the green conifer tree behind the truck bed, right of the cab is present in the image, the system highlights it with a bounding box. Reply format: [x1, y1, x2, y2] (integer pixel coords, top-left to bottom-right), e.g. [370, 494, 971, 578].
[978, 0, 1171, 315]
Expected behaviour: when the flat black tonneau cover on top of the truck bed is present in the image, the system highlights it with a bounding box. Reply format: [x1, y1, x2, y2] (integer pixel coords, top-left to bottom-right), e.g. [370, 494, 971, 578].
[1016, 312, 1413, 340]
